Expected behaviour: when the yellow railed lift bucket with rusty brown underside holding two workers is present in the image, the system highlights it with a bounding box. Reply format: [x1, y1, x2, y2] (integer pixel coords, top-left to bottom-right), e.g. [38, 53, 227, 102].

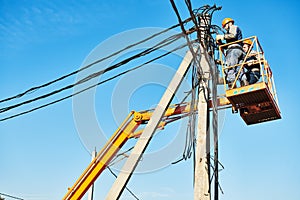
[219, 36, 281, 125]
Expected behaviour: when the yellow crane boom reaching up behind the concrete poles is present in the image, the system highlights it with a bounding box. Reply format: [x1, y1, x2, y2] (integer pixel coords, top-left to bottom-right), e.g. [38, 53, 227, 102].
[63, 98, 230, 200]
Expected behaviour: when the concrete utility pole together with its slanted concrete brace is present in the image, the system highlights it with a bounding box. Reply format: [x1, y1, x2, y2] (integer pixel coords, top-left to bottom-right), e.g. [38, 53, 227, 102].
[106, 8, 218, 200]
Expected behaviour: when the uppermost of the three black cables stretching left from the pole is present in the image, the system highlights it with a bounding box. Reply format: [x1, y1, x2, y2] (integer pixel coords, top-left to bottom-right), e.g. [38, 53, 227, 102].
[0, 18, 191, 103]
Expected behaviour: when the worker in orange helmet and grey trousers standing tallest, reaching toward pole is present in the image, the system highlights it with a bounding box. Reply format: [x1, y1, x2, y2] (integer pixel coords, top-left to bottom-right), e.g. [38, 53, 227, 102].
[216, 18, 243, 88]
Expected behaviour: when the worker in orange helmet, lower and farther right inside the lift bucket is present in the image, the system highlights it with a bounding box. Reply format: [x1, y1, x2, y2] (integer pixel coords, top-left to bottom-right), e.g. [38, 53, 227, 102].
[240, 39, 260, 86]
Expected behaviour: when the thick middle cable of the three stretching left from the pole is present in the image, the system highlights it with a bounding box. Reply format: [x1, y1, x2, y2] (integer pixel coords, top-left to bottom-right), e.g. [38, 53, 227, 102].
[0, 34, 182, 113]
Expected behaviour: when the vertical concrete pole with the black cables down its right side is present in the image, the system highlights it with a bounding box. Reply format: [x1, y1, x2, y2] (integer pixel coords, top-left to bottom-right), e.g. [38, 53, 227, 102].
[194, 14, 219, 200]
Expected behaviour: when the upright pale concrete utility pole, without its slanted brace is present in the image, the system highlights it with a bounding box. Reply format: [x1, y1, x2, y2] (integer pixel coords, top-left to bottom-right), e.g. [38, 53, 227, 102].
[194, 16, 215, 200]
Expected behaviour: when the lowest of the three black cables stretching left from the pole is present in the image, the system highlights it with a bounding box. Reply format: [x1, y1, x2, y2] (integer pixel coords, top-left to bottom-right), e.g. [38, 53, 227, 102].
[0, 41, 191, 121]
